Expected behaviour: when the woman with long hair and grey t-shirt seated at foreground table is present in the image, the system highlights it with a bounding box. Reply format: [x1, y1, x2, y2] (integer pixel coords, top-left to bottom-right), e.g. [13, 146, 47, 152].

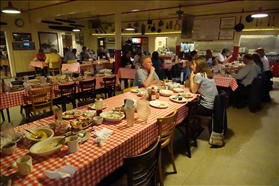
[190, 57, 218, 136]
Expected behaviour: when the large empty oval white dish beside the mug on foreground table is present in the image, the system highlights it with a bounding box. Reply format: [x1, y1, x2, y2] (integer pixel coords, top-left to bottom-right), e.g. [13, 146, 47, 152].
[30, 136, 66, 156]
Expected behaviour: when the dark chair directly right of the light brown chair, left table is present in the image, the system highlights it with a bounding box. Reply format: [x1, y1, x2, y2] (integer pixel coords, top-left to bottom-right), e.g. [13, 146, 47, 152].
[53, 83, 76, 112]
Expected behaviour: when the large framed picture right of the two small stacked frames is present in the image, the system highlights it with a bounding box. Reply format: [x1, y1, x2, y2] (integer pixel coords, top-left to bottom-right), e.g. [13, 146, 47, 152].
[38, 32, 59, 53]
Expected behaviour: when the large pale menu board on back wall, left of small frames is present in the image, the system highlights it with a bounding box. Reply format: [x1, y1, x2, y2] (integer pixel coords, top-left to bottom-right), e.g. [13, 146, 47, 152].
[192, 18, 220, 41]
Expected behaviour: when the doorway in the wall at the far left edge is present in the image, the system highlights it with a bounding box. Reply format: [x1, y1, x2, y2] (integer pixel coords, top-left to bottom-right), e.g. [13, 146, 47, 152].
[0, 31, 12, 79]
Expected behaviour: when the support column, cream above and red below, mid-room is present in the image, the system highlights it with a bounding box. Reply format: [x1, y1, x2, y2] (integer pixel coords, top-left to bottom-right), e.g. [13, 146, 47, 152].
[114, 11, 121, 74]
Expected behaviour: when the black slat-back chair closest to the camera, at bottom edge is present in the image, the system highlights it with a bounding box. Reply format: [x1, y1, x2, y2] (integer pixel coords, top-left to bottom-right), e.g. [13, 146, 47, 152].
[124, 136, 161, 186]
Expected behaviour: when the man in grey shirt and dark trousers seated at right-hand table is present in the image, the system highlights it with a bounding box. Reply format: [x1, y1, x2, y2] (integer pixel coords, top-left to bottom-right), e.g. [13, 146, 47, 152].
[232, 54, 258, 108]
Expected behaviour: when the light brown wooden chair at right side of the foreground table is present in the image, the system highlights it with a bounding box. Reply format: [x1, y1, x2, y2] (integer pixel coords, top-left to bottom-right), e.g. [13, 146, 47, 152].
[157, 109, 177, 185]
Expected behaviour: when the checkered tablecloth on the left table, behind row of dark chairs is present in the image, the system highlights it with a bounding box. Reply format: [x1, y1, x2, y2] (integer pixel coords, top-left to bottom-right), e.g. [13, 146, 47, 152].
[0, 74, 120, 109]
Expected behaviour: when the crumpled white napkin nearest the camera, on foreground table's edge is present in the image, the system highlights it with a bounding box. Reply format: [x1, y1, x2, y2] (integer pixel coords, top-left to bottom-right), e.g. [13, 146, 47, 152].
[44, 165, 77, 180]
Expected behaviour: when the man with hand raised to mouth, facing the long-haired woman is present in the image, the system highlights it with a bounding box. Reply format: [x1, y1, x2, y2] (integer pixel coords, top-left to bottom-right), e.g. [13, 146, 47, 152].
[133, 56, 159, 88]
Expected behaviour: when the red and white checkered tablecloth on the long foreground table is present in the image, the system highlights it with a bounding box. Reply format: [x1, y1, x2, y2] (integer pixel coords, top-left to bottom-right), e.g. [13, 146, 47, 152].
[1, 89, 197, 186]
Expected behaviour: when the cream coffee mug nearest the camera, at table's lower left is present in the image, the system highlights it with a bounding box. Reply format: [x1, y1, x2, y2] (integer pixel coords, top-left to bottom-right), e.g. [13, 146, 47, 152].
[16, 155, 33, 176]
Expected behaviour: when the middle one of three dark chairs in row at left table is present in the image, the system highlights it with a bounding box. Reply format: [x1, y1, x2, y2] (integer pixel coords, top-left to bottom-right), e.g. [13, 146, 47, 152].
[77, 79, 96, 100]
